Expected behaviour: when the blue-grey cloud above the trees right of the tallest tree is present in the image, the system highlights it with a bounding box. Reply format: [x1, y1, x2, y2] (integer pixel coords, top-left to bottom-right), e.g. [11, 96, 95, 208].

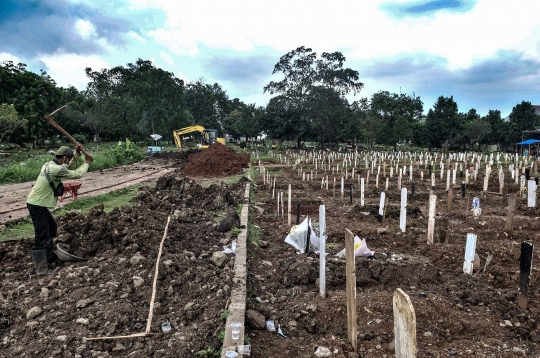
[355, 51, 540, 113]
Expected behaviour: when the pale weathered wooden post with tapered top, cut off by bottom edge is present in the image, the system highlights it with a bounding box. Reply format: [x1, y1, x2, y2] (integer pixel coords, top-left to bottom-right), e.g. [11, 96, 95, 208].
[392, 288, 416, 358]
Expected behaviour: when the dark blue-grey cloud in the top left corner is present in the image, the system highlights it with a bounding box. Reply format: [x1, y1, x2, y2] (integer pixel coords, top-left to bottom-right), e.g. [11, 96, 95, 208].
[0, 0, 128, 58]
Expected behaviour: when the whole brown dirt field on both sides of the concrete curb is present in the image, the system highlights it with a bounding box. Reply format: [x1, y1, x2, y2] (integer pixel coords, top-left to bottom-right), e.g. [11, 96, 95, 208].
[0, 147, 540, 358]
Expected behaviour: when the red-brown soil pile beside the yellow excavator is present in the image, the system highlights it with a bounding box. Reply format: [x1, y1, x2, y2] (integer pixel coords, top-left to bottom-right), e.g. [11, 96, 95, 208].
[183, 143, 249, 177]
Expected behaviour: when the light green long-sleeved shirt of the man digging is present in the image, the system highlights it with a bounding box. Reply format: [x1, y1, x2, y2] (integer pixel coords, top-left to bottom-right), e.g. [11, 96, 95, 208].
[26, 153, 88, 208]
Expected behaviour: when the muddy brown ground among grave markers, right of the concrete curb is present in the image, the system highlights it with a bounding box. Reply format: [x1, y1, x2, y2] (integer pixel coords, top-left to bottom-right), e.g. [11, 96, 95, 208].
[248, 156, 540, 358]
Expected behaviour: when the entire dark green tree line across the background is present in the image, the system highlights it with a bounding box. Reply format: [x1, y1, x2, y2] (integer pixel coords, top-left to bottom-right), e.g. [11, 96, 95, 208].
[0, 47, 540, 150]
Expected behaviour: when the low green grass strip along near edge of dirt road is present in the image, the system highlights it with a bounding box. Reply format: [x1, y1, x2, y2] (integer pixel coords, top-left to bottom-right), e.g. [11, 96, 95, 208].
[0, 184, 148, 241]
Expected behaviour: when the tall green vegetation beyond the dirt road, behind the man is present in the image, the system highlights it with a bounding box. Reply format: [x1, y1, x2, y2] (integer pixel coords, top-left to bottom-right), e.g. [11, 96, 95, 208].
[0, 139, 144, 184]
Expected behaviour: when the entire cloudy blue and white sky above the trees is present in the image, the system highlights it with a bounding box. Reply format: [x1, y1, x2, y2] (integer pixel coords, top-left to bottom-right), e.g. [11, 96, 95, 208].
[0, 0, 540, 117]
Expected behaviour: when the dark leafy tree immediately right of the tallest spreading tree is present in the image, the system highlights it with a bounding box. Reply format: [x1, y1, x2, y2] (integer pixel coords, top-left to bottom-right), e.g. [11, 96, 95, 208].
[370, 91, 424, 150]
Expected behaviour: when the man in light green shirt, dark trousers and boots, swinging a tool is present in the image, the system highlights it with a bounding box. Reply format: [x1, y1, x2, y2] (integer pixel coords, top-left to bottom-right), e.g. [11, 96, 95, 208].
[26, 143, 94, 277]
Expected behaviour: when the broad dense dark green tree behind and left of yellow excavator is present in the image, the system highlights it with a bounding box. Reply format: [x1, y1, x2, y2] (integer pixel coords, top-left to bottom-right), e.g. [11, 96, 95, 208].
[84, 59, 192, 138]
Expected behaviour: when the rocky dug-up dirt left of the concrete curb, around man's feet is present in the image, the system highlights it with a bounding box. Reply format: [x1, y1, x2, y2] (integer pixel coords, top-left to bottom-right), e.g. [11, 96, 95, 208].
[0, 171, 249, 358]
